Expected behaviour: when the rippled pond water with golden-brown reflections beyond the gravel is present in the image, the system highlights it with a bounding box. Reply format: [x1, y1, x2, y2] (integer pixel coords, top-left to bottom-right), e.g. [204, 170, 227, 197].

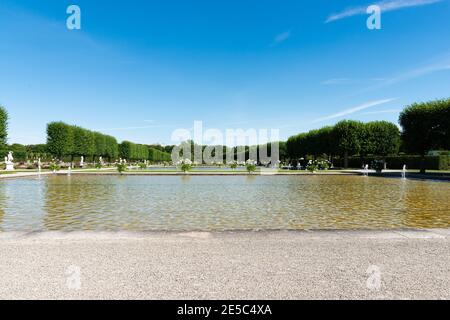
[0, 175, 450, 231]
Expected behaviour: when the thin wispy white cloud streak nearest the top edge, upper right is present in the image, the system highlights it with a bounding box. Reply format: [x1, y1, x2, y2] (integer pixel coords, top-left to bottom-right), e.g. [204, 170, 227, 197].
[325, 0, 444, 23]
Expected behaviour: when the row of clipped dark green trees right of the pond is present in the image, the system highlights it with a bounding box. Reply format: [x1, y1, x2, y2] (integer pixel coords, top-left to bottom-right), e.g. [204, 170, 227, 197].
[286, 99, 450, 172]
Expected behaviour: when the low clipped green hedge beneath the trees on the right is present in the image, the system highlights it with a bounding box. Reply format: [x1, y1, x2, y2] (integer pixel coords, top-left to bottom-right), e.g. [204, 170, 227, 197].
[333, 155, 450, 170]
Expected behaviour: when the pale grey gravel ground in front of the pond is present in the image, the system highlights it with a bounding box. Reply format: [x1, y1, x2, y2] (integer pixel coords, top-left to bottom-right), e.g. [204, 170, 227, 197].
[0, 229, 450, 299]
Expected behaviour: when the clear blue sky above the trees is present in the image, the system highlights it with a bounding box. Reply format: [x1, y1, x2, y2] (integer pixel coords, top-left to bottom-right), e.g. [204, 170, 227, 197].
[0, 0, 450, 144]
